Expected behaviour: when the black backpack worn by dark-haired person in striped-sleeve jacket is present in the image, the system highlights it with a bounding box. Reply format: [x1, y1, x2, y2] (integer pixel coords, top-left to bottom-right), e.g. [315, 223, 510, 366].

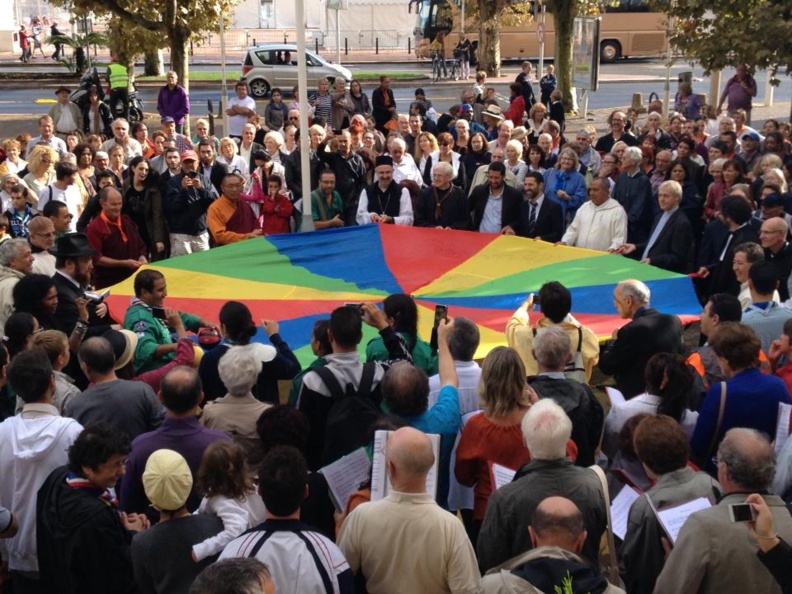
[313, 361, 384, 466]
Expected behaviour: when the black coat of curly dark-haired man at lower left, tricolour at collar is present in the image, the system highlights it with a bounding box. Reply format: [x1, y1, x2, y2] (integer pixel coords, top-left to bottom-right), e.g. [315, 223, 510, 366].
[37, 466, 137, 594]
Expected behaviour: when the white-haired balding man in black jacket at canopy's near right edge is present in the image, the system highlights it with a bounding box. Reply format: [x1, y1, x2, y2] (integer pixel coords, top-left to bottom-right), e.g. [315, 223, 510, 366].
[599, 280, 683, 398]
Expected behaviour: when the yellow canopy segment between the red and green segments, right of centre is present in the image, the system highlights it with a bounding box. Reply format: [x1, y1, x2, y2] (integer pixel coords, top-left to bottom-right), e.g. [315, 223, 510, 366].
[414, 235, 602, 297]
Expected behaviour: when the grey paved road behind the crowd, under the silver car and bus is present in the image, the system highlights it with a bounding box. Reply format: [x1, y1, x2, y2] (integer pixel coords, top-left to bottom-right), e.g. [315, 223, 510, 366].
[0, 60, 792, 114]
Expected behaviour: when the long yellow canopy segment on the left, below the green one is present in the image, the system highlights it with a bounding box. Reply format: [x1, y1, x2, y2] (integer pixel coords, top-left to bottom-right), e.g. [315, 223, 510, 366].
[112, 268, 374, 302]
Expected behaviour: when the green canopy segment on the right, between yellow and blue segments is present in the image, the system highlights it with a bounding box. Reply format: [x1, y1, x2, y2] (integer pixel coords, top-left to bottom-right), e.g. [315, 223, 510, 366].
[432, 255, 680, 299]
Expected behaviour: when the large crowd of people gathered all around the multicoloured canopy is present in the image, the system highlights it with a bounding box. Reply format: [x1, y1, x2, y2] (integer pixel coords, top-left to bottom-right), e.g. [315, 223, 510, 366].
[0, 63, 792, 594]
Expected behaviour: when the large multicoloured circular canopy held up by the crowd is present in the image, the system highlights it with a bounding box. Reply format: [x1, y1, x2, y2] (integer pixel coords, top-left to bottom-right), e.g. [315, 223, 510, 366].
[103, 225, 701, 363]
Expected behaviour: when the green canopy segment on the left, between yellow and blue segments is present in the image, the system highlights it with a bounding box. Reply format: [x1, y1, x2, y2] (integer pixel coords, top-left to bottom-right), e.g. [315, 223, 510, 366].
[157, 239, 388, 297]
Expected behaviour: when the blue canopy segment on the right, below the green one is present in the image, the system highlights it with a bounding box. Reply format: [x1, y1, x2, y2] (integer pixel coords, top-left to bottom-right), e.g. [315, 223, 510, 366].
[420, 276, 701, 315]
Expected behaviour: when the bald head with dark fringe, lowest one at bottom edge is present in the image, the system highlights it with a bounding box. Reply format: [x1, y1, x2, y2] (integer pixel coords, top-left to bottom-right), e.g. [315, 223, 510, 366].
[528, 497, 586, 553]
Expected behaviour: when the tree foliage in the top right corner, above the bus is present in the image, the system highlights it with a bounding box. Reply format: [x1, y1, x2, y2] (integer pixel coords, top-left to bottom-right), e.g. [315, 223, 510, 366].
[657, 0, 792, 76]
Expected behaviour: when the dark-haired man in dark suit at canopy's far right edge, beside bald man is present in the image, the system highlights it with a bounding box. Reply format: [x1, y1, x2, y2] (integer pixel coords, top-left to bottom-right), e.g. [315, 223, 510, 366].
[698, 195, 760, 302]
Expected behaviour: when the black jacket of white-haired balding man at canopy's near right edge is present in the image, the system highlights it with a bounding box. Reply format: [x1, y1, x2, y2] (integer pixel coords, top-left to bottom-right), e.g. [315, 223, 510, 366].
[599, 307, 683, 398]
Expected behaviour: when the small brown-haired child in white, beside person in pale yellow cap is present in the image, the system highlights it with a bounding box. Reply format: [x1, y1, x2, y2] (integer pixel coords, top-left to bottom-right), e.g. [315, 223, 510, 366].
[192, 441, 265, 563]
